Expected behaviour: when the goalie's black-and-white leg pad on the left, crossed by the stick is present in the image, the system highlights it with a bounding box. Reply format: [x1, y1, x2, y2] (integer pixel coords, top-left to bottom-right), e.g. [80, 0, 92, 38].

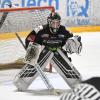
[14, 50, 53, 91]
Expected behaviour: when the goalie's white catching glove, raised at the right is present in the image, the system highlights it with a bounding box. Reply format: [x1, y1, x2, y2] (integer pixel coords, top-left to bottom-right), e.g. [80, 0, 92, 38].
[66, 35, 82, 54]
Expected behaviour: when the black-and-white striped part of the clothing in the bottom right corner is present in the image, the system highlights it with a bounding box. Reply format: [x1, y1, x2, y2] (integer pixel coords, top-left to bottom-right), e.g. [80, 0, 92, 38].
[60, 83, 100, 100]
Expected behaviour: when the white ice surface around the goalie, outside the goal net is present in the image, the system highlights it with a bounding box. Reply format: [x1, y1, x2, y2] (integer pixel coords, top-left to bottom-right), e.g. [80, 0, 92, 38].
[0, 32, 100, 100]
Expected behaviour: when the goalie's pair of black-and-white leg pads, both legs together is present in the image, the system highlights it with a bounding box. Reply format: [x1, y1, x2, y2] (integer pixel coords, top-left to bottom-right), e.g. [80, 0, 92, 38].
[14, 48, 81, 91]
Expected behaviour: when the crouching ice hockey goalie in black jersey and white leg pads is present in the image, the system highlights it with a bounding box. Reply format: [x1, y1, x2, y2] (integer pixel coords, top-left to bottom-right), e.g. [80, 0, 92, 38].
[14, 13, 82, 91]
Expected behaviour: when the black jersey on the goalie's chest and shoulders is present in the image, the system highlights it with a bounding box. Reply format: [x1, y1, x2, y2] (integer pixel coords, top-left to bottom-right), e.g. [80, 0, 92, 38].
[35, 26, 73, 48]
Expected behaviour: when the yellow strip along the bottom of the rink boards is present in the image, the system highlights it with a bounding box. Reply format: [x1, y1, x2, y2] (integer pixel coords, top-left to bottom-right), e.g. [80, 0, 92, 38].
[0, 26, 100, 40]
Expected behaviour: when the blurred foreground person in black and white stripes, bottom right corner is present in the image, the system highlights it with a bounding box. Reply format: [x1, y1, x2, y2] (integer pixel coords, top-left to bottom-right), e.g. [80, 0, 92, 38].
[59, 77, 100, 100]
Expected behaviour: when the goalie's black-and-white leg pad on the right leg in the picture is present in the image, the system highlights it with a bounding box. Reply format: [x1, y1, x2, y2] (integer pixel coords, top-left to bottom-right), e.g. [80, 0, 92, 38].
[51, 49, 81, 88]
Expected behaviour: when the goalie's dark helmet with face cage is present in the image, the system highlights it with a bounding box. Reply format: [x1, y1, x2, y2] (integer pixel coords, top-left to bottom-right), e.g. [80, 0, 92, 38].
[47, 13, 61, 34]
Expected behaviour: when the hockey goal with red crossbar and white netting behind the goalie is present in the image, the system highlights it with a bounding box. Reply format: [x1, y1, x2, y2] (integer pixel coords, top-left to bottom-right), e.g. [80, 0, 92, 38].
[0, 7, 55, 69]
